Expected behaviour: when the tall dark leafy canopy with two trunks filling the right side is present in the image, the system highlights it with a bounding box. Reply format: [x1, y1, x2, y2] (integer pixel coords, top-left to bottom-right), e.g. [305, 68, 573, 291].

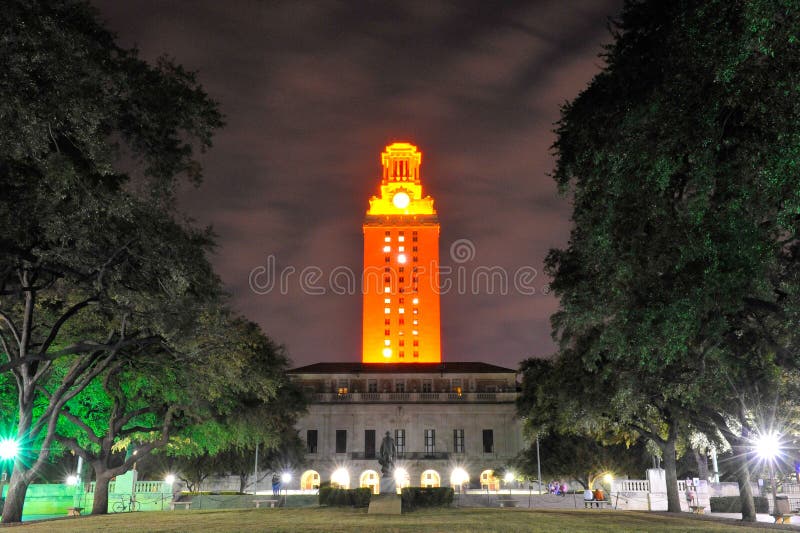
[547, 0, 800, 520]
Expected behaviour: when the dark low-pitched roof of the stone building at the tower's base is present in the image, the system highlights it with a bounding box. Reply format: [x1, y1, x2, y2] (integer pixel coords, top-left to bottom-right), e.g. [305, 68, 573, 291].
[289, 361, 517, 374]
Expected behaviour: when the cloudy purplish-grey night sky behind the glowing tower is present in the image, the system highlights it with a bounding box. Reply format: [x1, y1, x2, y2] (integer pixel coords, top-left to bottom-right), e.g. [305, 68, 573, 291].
[94, 0, 621, 368]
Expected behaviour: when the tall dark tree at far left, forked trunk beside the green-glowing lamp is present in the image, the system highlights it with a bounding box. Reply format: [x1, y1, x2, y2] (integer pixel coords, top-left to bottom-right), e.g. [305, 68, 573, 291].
[0, 0, 221, 523]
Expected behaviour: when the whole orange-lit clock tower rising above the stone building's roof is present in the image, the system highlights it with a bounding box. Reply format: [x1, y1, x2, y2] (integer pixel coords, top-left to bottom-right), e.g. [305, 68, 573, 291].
[361, 143, 442, 363]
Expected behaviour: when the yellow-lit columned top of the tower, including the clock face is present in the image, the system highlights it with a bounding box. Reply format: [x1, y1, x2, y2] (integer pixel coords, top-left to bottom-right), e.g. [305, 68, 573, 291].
[367, 142, 436, 215]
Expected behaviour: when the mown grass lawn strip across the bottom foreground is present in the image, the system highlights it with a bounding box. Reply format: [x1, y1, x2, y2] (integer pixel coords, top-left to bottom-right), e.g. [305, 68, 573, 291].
[1, 507, 788, 533]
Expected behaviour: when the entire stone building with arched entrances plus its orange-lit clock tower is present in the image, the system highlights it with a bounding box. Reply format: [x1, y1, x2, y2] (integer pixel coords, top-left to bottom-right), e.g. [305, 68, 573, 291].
[290, 143, 524, 492]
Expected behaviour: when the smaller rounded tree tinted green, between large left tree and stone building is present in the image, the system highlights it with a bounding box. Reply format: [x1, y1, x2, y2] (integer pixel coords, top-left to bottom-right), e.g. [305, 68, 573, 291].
[56, 310, 304, 514]
